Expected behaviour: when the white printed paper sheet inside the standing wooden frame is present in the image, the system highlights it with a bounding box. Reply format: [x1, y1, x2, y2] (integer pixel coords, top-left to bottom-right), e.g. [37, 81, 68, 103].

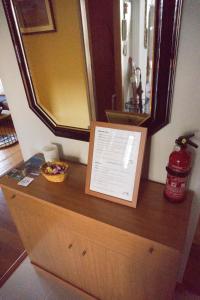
[90, 126, 141, 201]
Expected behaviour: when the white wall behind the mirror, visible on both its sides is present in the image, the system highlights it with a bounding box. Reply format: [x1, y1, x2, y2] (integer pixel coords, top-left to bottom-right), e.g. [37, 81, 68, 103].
[0, 0, 200, 282]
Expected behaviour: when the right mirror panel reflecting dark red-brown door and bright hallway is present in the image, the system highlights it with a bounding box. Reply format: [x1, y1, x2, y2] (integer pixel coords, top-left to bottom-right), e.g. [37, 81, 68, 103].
[87, 0, 156, 125]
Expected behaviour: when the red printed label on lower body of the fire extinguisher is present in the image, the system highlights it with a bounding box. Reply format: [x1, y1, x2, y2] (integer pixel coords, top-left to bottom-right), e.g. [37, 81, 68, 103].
[165, 174, 187, 200]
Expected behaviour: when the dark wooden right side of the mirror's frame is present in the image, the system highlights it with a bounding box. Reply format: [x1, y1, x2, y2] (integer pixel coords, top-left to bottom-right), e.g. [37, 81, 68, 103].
[144, 0, 183, 134]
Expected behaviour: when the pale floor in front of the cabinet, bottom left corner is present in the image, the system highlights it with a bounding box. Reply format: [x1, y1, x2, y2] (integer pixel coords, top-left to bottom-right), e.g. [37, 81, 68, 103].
[0, 258, 94, 300]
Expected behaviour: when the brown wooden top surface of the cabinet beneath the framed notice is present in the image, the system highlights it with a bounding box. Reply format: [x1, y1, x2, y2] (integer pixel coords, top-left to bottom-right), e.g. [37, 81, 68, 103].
[0, 163, 193, 251]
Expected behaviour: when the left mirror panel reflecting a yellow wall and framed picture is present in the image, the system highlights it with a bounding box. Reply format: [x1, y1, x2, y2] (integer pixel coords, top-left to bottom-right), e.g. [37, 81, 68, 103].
[13, 0, 92, 129]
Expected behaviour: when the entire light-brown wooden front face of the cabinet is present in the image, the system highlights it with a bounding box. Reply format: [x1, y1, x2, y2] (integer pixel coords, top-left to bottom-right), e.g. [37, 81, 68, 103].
[1, 188, 180, 300]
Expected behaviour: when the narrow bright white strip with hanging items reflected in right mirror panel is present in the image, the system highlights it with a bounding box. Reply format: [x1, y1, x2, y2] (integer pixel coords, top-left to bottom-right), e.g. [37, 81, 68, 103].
[120, 0, 155, 114]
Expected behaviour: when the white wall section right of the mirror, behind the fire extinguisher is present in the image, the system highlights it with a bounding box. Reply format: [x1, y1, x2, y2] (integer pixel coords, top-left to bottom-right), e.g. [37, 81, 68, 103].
[149, 0, 200, 278]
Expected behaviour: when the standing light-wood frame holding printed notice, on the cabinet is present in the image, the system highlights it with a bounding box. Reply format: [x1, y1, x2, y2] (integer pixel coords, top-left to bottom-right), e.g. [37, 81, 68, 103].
[85, 121, 147, 208]
